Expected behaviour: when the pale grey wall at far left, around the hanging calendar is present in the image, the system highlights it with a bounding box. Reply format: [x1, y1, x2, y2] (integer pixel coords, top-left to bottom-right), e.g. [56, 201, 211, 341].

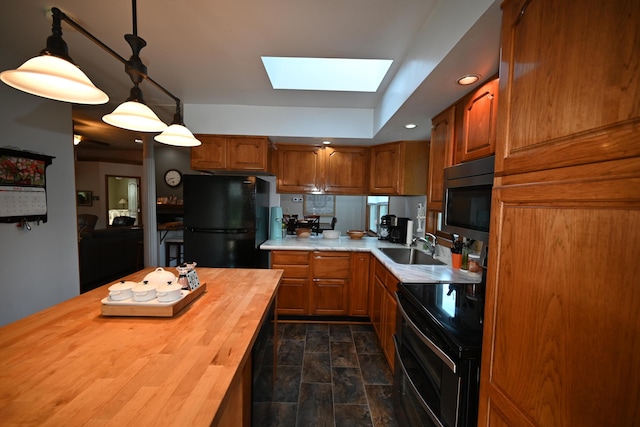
[0, 47, 80, 325]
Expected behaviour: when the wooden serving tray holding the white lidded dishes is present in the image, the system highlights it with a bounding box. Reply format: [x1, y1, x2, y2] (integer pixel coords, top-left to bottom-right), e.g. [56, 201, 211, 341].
[101, 283, 207, 317]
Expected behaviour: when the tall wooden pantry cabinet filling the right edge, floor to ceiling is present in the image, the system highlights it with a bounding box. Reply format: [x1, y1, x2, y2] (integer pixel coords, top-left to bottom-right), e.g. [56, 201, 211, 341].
[478, 0, 640, 426]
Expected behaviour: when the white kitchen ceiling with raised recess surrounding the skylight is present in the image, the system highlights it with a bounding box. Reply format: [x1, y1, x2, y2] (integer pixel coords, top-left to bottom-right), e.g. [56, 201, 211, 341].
[0, 0, 501, 157]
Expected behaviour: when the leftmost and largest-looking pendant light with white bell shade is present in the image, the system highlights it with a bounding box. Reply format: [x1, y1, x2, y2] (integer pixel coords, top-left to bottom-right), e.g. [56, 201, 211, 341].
[0, 8, 109, 104]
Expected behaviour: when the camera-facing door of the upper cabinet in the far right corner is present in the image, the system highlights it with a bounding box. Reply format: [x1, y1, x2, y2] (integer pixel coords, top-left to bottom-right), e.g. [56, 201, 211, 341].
[369, 143, 400, 195]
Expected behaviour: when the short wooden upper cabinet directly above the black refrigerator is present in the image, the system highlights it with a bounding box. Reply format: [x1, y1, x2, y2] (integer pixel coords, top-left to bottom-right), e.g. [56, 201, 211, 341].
[191, 135, 269, 172]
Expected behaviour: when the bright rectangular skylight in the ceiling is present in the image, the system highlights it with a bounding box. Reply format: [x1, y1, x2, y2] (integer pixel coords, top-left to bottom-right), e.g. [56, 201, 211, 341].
[262, 56, 393, 92]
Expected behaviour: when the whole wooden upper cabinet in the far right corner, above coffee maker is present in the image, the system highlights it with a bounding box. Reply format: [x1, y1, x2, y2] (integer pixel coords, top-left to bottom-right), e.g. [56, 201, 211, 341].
[369, 141, 429, 196]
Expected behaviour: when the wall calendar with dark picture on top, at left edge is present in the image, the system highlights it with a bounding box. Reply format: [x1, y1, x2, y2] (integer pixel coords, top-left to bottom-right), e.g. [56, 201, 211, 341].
[0, 148, 53, 223]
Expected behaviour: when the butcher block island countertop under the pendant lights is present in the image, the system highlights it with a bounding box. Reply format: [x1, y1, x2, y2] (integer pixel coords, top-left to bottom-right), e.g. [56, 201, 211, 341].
[0, 267, 282, 426]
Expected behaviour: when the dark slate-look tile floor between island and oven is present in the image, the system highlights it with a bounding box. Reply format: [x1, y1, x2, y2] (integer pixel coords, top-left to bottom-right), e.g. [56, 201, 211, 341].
[253, 323, 398, 427]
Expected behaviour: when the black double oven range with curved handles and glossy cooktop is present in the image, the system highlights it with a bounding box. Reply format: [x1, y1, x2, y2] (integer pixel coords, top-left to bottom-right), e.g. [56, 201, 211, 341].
[394, 280, 484, 427]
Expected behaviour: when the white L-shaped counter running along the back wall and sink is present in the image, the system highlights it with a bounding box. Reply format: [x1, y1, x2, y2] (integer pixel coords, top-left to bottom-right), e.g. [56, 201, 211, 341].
[260, 235, 482, 283]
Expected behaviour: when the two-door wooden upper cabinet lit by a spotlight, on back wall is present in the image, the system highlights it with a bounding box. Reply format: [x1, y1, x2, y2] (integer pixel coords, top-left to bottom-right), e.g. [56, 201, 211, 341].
[274, 144, 369, 194]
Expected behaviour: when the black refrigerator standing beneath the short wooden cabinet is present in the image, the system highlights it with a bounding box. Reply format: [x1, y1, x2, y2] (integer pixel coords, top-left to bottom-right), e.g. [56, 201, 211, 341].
[183, 175, 269, 268]
